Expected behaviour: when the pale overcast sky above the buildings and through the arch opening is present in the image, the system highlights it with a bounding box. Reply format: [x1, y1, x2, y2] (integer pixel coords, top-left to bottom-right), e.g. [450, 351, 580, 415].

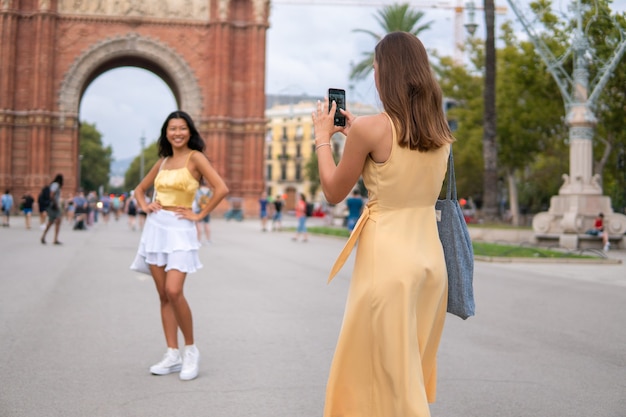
[80, 0, 626, 160]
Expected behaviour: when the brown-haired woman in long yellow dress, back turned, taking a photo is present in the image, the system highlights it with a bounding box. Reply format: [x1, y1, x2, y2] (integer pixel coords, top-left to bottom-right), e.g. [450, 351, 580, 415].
[313, 32, 454, 417]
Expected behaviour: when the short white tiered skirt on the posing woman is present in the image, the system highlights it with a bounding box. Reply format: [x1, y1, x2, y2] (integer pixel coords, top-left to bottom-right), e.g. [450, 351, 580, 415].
[130, 210, 202, 274]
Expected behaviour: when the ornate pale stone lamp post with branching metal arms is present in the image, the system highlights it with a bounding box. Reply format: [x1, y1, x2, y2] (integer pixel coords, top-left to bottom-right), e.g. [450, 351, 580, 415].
[508, 0, 626, 248]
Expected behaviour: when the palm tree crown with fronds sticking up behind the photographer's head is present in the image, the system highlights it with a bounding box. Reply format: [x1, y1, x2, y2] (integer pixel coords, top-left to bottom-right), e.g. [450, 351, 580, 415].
[350, 3, 433, 80]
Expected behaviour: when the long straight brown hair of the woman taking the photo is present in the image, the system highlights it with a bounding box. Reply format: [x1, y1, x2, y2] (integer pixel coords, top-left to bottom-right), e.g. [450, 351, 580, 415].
[374, 32, 454, 152]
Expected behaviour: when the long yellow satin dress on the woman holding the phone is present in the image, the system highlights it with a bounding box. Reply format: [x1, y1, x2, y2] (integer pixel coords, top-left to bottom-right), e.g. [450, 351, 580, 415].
[324, 114, 450, 417]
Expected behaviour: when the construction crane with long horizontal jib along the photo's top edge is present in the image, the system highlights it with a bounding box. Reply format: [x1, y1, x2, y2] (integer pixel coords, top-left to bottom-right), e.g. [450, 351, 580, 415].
[272, 0, 507, 63]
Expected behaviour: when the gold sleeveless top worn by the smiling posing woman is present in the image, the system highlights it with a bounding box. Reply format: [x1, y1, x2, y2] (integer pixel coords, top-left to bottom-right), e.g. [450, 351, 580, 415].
[154, 151, 200, 208]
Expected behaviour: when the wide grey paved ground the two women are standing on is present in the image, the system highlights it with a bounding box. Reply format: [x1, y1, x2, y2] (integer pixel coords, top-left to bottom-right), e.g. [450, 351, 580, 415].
[0, 218, 626, 417]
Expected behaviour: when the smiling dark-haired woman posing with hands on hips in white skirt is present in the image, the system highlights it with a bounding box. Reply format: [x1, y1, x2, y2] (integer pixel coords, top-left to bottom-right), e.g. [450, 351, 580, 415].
[131, 111, 228, 380]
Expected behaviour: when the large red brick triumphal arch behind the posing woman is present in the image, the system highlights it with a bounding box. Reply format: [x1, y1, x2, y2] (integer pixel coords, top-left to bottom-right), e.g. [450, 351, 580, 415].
[0, 0, 269, 210]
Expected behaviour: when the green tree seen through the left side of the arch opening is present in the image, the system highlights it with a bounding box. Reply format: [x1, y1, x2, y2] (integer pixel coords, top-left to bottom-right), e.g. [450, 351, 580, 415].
[79, 122, 113, 192]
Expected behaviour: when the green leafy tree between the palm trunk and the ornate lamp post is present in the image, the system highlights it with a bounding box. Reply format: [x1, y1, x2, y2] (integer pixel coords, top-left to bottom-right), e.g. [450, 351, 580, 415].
[496, 23, 567, 225]
